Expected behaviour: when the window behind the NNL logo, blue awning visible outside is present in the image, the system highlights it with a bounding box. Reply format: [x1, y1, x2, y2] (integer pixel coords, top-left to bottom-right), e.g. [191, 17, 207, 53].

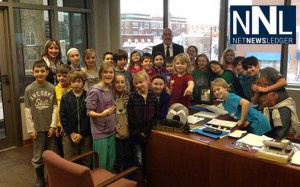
[227, 0, 284, 71]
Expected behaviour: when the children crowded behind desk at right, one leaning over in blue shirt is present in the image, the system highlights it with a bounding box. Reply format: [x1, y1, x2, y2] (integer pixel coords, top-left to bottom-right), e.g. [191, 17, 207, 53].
[192, 49, 300, 139]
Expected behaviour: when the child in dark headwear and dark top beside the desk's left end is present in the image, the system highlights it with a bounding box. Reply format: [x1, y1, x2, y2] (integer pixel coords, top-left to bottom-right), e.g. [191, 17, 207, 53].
[151, 75, 170, 119]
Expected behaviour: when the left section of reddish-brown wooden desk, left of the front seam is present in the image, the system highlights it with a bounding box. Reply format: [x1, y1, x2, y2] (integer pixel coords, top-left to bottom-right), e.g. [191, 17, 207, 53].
[147, 130, 214, 187]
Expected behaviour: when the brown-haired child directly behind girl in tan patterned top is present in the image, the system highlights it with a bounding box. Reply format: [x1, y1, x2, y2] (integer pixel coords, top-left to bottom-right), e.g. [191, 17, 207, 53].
[113, 49, 132, 91]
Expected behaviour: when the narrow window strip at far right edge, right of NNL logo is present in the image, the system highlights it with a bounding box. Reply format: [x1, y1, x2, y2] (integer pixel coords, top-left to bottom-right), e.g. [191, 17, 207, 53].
[287, 0, 300, 85]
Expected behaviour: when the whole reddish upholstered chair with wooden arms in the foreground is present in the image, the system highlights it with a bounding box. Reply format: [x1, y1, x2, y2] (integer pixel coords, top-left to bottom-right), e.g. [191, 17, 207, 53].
[43, 150, 141, 187]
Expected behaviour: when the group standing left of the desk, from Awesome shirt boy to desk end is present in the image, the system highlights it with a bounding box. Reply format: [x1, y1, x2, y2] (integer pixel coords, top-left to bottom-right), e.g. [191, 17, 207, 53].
[25, 40, 192, 186]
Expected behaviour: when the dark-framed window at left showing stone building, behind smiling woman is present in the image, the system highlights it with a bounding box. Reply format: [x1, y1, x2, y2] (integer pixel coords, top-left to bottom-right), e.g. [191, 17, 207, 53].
[13, 0, 91, 96]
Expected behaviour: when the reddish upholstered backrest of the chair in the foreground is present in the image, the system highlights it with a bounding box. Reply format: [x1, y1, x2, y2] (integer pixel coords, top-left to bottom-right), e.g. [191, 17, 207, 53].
[43, 150, 94, 187]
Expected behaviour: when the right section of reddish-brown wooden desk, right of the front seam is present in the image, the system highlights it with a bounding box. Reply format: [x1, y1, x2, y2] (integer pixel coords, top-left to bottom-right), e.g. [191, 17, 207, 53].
[209, 137, 300, 187]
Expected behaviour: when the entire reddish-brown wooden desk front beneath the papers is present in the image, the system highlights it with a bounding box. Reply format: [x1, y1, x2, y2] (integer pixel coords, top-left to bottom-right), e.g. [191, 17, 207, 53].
[146, 130, 300, 187]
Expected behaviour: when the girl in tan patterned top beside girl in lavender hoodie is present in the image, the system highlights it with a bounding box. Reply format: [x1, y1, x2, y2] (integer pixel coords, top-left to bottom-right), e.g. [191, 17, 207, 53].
[114, 73, 130, 173]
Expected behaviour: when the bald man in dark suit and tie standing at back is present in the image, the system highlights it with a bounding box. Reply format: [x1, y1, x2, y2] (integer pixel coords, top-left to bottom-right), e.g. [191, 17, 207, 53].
[152, 28, 184, 59]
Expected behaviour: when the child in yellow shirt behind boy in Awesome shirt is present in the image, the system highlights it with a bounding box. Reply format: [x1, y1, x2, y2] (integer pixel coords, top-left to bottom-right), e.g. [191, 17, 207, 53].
[55, 64, 72, 157]
